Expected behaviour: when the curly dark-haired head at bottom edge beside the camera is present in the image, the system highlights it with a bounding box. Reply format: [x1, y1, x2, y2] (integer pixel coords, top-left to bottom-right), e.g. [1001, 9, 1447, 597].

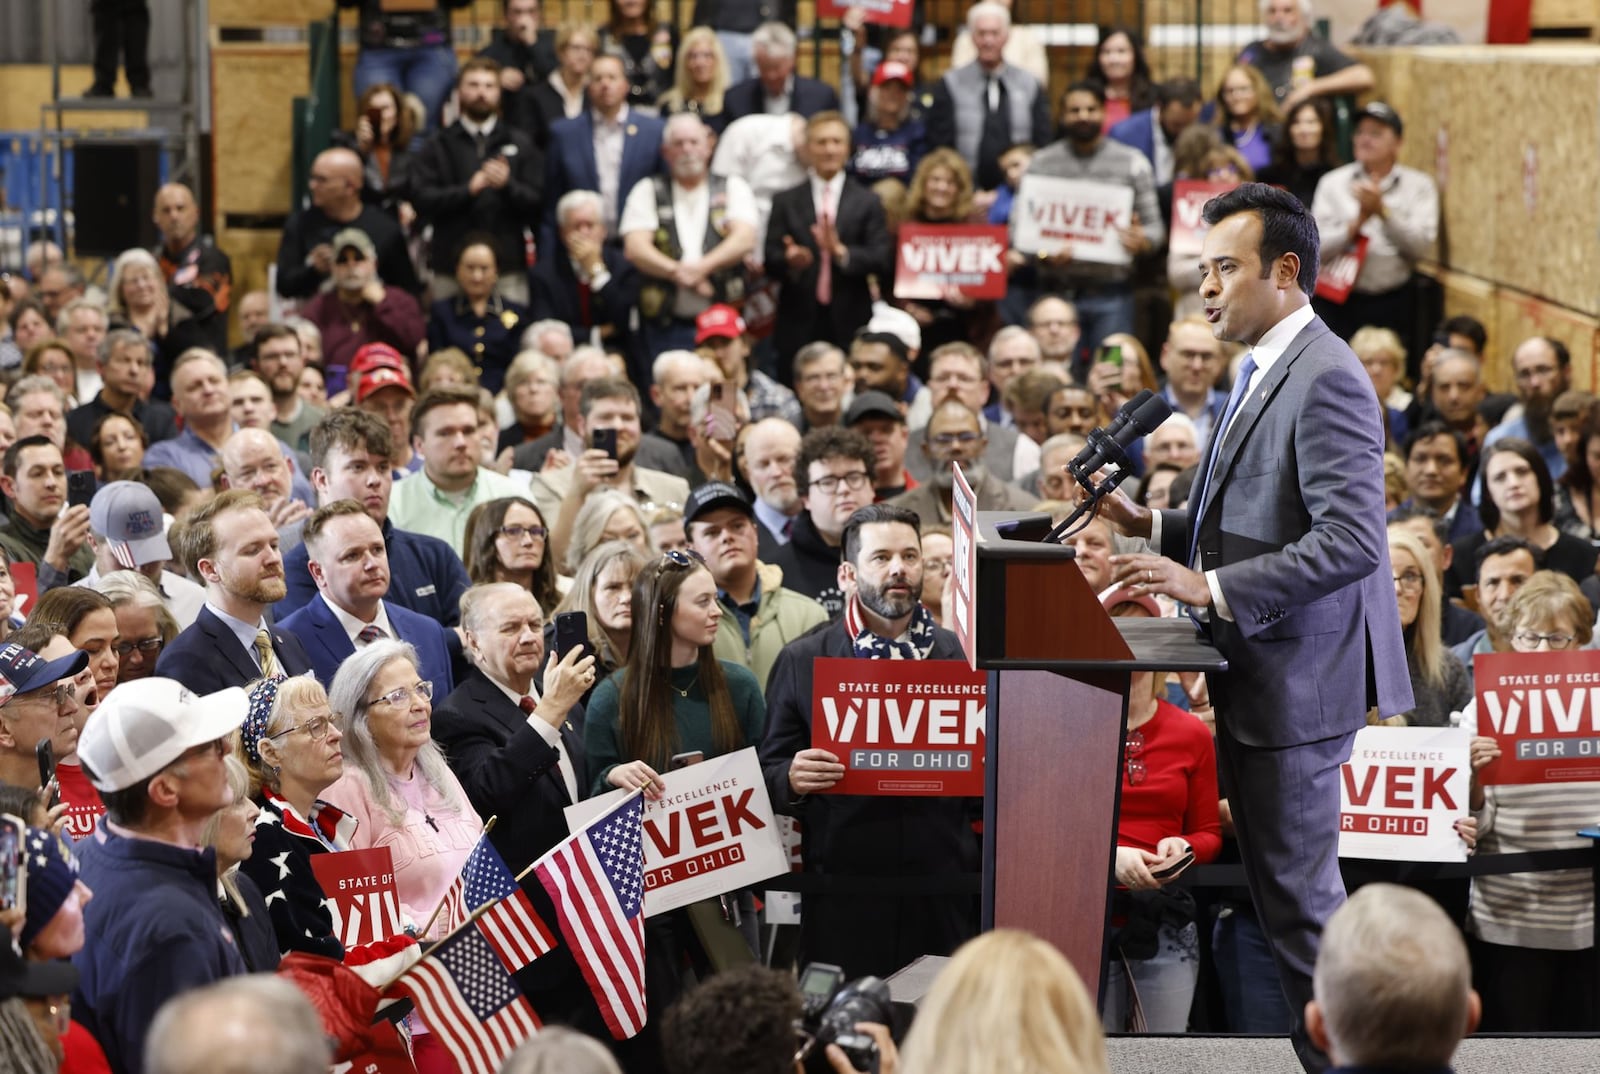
[661, 965, 800, 1074]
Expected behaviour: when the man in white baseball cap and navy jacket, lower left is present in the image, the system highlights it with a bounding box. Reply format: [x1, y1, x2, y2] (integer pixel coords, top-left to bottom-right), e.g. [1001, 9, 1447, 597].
[72, 681, 249, 1074]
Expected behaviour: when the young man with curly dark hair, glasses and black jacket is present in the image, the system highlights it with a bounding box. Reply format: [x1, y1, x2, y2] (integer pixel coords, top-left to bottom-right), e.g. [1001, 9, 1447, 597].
[773, 426, 877, 618]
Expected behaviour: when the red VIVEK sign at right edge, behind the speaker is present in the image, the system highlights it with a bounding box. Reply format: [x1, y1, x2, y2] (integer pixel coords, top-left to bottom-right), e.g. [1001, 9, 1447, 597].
[1472, 650, 1600, 786]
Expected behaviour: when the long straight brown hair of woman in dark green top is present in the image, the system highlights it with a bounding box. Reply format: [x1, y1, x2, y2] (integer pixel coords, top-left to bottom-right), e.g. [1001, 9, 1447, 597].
[618, 552, 746, 771]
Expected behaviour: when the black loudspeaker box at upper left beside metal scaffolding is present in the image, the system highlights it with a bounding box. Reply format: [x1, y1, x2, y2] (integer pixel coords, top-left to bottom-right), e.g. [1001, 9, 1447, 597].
[72, 141, 162, 258]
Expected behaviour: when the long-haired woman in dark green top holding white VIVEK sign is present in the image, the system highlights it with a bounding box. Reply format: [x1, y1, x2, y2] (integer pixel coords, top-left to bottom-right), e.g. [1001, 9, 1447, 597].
[584, 552, 766, 1012]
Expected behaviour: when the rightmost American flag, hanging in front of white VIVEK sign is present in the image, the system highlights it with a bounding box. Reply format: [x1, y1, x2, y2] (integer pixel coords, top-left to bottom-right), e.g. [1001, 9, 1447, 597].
[533, 794, 645, 1040]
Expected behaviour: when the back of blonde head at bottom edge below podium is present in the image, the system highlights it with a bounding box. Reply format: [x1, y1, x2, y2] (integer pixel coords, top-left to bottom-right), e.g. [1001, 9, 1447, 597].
[899, 928, 1107, 1074]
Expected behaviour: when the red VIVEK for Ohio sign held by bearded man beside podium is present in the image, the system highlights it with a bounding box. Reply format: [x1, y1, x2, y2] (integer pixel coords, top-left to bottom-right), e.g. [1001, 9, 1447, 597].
[811, 656, 989, 797]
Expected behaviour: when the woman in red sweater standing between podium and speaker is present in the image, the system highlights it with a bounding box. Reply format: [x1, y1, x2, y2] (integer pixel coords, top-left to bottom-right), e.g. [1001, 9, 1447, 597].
[1102, 591, 1222, 1032]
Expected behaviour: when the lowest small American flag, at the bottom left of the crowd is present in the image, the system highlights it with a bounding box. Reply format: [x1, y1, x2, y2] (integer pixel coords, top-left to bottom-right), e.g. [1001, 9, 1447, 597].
[392, 928, 539, 1074]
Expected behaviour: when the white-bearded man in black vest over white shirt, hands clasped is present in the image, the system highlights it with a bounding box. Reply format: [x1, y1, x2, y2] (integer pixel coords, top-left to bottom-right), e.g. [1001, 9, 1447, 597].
[618, 112, 757, 377]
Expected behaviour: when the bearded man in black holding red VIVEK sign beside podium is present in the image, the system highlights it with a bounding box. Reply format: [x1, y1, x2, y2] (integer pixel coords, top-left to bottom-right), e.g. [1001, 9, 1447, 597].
[760, 504, 978, 978]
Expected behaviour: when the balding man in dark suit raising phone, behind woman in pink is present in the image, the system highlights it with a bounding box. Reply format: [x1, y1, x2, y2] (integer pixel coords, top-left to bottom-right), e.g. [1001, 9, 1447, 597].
[434, 583, 603, 1032]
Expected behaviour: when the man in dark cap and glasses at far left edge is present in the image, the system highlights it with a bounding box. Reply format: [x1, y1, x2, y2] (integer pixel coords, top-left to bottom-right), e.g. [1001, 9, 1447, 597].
[0, 642, 90, 787]
